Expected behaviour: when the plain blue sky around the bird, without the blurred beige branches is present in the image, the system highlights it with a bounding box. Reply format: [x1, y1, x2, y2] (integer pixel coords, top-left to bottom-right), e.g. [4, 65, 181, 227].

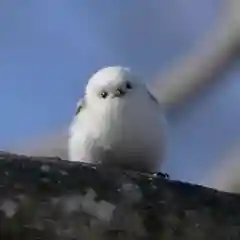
[0, 0, 240, 184]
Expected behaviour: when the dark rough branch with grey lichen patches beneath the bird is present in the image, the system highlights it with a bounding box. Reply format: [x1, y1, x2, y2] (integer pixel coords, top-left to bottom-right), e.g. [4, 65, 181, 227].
[0, 153, 240, 240]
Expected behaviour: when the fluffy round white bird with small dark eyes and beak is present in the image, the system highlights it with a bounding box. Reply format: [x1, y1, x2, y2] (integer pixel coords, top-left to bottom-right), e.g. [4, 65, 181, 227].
[68, 66, 166, 172]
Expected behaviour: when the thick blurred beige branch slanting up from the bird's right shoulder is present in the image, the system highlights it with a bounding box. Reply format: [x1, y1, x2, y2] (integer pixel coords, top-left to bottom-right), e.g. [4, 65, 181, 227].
[149, 0, 240, 108]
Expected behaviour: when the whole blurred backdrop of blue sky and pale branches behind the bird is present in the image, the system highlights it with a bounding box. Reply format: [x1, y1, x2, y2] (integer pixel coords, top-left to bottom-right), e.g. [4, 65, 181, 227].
[0, 0, 240, 191]
